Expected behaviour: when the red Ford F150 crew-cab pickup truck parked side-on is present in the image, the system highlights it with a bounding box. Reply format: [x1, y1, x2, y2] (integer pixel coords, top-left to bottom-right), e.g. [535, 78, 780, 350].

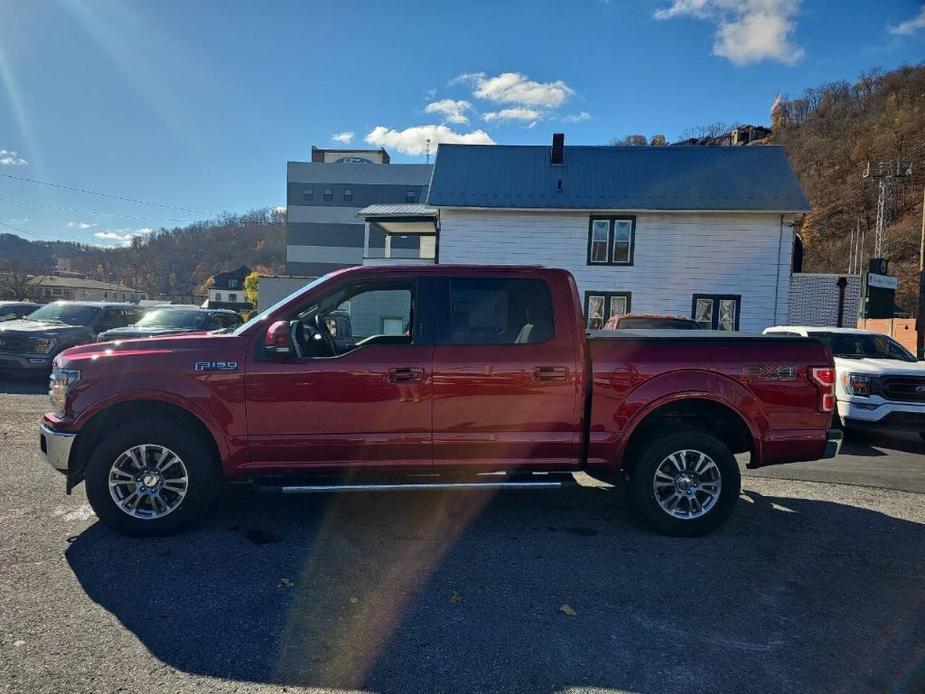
[41, 265, 841, 535]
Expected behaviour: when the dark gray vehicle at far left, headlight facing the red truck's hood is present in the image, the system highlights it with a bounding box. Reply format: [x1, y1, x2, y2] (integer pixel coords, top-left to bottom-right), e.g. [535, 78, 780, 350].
[0, 301, 142, 373]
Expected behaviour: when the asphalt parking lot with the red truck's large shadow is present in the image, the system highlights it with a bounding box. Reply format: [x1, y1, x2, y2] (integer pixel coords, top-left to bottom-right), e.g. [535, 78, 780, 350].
[0, 382, 925, 692]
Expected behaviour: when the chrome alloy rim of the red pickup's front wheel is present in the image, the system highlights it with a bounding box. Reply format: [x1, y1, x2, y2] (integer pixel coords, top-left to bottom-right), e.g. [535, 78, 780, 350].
[109, 443, 189, 520]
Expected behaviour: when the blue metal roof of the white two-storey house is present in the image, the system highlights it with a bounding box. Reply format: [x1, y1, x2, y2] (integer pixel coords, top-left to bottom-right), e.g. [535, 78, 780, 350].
[427, 144, 810, 212]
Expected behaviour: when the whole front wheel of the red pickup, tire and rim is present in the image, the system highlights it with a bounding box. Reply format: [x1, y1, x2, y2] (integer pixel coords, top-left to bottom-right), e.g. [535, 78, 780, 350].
[86, 420, 219, 536]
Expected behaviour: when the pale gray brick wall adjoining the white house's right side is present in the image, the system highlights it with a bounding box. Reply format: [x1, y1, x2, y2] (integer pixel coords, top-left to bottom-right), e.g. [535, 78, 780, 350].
[787, 272, 861, 328]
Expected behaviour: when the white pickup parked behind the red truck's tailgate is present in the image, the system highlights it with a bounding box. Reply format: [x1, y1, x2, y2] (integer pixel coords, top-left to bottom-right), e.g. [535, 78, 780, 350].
[764, 325, 925, 440]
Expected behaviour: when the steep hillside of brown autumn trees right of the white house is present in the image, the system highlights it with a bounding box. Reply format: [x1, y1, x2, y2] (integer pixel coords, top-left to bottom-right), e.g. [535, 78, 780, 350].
[769, 65, 925, 312]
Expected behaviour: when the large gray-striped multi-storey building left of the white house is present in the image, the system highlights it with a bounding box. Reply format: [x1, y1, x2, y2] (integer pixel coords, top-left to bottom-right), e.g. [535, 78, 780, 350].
[286, 147, 433, 278]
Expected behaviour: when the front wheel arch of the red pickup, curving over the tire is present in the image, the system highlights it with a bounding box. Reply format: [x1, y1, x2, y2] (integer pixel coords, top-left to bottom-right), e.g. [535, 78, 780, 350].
[67, 398, 223, 493]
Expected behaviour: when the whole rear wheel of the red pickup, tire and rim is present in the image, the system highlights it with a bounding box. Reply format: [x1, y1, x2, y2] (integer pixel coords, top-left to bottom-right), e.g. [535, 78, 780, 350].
[629, 429, 741, 537]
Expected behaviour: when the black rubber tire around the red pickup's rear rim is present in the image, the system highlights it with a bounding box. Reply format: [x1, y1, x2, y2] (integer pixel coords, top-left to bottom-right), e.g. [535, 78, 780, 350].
[629, 429, 742, 537]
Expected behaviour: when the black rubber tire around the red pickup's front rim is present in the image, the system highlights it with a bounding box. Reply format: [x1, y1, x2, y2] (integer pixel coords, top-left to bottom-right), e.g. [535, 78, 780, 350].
[86, 419, 220, 537]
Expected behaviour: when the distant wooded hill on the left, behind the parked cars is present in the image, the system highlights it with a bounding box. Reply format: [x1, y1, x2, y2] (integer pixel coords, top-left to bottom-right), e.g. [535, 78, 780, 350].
[0, 208, 286, 295]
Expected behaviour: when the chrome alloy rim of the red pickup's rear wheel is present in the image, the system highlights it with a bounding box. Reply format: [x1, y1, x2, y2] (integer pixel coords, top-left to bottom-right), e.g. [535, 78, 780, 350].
[652, 450, 723, 519]
